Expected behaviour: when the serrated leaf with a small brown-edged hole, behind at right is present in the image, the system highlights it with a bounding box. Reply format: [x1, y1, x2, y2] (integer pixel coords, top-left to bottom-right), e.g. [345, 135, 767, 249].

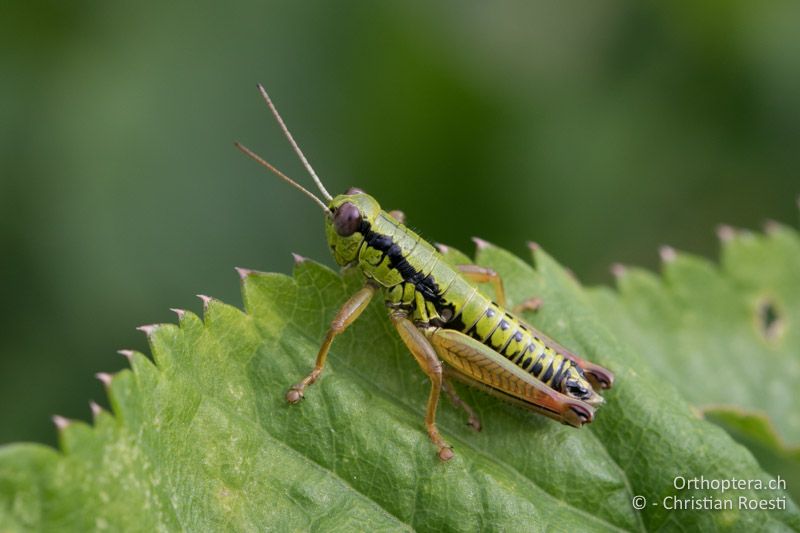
[593, 224, 800, 497]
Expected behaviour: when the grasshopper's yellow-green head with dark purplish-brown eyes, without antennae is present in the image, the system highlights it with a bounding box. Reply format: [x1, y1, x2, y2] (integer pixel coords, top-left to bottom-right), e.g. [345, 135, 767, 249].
[325, 188, 381, 266]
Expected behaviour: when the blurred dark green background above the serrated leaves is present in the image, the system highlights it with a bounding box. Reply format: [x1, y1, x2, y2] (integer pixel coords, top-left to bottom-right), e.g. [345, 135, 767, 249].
[0, 0, 800, 443]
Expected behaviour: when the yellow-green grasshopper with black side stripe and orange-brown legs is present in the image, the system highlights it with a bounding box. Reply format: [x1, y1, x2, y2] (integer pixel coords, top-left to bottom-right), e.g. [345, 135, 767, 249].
[236, 85, 614, 461]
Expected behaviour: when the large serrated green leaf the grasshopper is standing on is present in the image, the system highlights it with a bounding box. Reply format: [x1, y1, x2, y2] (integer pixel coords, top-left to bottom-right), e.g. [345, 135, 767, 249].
[0, 239, 800, 531]
